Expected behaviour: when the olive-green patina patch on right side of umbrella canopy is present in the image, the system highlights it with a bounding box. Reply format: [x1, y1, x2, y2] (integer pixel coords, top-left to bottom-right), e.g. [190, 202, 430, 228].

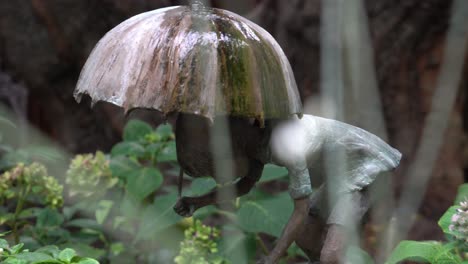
[212, 11, 289, 118]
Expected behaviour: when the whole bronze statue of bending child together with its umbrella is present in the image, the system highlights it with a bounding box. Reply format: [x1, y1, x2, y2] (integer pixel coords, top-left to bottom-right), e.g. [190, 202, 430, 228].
[75, 3, 399, 263]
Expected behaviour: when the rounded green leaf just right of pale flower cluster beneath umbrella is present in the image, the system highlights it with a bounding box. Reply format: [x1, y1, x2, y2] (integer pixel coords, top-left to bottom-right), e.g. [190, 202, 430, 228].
[127, 167, 163, 201]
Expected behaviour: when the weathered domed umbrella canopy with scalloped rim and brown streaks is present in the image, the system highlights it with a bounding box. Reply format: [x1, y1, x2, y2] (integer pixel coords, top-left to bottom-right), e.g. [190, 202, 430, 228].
[75, 3, 302, 120]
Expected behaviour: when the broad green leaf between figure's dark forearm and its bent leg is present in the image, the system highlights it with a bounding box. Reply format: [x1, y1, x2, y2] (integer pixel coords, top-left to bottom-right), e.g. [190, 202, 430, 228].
[237, 192, 293, 237]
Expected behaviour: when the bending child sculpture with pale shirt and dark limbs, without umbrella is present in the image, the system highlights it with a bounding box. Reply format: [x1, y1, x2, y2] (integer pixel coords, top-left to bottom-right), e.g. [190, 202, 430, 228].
[174, 114, 401, 263]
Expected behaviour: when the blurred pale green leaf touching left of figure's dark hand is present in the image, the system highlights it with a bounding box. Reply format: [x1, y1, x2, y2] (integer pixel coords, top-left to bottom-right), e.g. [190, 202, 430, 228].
[137, 193, 182, 240]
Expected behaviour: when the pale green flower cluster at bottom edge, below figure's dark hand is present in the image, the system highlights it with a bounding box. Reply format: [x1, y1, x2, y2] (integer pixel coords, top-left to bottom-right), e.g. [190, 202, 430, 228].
[174, 220, 227, 264]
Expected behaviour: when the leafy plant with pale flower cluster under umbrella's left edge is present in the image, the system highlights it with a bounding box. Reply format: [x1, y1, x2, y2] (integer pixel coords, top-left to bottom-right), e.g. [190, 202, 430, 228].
[64, 120, 182, 262]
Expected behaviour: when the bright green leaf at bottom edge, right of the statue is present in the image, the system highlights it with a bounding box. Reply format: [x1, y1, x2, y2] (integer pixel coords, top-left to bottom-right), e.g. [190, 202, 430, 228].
[385, 240, 442, 264]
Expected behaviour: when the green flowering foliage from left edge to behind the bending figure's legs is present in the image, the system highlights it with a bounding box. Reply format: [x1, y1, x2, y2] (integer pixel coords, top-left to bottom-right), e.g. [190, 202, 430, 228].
[0, 120, 374, 263]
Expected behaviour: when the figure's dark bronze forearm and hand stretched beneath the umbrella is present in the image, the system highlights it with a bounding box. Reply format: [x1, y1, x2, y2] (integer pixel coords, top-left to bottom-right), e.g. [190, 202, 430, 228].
[174, 160, 264, 217]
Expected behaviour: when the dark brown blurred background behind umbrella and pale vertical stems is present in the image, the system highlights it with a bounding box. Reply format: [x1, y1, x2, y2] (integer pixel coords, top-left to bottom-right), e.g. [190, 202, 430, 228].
[0, 0, 468, 256]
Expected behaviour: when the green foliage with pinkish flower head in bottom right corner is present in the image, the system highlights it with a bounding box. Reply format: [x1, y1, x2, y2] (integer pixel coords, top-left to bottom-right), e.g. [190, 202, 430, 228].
[386, 184, 468, 264]
